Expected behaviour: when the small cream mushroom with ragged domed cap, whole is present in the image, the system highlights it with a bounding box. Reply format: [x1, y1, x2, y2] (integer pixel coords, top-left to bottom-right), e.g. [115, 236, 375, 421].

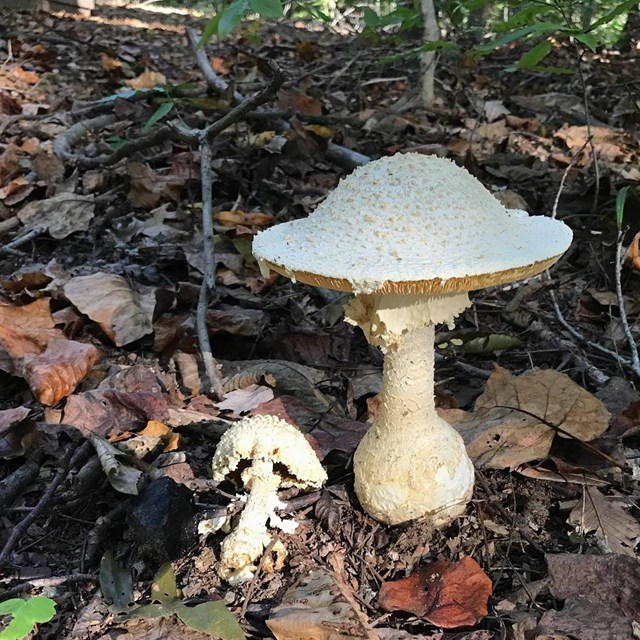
[212, 415, 327, 584]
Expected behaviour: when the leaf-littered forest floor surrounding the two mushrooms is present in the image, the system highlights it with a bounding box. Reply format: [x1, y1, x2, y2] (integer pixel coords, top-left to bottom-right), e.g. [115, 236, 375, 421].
[0, 9, 640, 640]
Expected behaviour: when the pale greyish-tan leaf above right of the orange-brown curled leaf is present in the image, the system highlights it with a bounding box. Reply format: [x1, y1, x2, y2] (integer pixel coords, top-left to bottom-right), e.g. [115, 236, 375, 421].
[64, 272, 153, 347]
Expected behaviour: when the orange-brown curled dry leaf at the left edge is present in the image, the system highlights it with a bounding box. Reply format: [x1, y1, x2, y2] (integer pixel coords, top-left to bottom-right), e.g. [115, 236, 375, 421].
[0, 298, 100, 405]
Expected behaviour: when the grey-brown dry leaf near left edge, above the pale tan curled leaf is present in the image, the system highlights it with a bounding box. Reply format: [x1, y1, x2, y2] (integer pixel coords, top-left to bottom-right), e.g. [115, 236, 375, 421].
[18, 193, 96, 240]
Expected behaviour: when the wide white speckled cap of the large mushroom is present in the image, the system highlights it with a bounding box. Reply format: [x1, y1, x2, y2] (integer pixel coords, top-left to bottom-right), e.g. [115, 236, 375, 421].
[253, 153, 573, 295]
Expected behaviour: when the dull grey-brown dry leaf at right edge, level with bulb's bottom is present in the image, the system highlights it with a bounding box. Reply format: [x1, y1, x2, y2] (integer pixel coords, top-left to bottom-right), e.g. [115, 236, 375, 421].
[569, 487, 640, 557]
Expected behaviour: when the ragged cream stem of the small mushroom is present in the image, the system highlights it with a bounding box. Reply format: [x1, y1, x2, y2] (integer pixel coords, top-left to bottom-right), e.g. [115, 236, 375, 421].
[219, 458, 281, 584]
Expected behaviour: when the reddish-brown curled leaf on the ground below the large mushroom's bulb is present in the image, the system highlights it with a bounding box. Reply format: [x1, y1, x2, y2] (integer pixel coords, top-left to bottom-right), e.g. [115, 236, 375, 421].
[378, 556, 492, 629]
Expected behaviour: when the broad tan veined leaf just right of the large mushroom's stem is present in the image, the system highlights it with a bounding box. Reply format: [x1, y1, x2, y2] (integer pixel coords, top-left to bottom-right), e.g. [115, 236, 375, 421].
[475, 367, 611, 442]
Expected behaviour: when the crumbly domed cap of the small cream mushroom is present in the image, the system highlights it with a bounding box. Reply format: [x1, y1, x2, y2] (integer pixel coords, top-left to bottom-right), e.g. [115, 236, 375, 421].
[212, 415, 327, 489]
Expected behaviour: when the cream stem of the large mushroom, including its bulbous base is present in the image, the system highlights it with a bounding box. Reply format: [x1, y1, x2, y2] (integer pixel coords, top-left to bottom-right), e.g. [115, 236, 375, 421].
[347, 296, 474, 527]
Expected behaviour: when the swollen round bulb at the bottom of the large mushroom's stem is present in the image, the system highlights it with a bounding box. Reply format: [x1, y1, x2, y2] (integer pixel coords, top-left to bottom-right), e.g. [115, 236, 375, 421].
[354, 416, 474, 529]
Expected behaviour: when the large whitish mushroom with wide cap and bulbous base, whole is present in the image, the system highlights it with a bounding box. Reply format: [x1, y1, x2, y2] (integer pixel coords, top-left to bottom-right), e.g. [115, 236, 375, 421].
[253, 153, 572, 527]
